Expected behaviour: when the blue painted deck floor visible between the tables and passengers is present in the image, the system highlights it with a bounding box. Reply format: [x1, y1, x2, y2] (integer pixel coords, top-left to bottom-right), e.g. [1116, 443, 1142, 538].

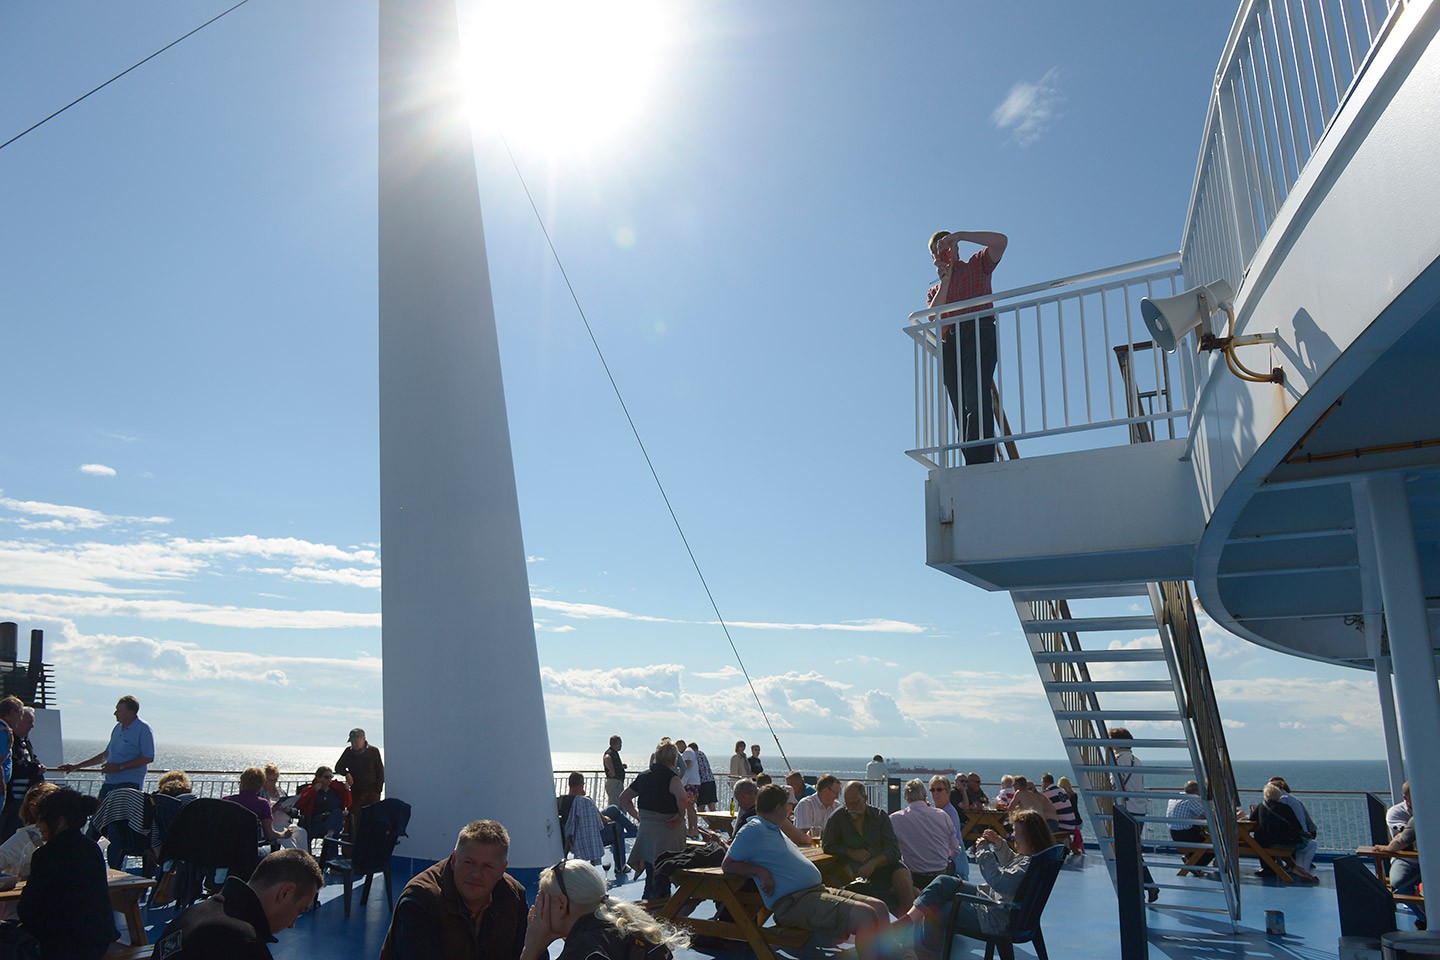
[135, 851, 1413, 960]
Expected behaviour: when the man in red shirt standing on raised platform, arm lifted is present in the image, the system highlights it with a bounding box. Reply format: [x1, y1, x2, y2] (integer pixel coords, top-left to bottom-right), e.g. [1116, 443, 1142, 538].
[924, 230, 1009, 463]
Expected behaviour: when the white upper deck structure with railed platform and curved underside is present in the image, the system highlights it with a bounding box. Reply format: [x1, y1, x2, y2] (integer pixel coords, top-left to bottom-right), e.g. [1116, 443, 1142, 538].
[906, 0, 1440, 932]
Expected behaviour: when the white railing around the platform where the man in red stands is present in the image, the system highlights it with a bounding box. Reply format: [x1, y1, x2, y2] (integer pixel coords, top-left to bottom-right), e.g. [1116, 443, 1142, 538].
[906, 253, 1197, 468]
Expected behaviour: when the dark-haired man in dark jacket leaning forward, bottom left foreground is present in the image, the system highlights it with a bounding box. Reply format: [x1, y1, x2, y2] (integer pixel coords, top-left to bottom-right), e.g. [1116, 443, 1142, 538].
[154, 849, 324, 960]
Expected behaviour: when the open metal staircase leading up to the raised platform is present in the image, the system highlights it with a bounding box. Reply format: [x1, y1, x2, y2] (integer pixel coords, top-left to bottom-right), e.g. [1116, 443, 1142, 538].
[1011, 581, 1240, 923]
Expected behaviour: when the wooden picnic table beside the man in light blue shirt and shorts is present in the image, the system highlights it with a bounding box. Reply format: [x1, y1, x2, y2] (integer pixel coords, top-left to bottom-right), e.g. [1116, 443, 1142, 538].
[655, 846, 835, 960]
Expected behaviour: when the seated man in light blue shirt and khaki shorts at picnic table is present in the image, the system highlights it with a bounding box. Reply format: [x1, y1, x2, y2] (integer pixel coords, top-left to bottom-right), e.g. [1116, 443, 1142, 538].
[720, 784, 890, 960]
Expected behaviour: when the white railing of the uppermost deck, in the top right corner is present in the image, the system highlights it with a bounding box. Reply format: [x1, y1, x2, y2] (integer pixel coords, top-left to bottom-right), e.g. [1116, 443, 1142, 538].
[1181, 0, 1404, 291]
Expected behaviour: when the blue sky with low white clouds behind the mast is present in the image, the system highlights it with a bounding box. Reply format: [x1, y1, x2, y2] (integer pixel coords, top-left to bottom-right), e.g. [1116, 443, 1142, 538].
[0, 0, 1380, 757]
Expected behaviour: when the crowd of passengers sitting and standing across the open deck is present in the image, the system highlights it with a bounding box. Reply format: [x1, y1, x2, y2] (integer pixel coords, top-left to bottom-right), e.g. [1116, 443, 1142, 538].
[0, 698, 1376, 960]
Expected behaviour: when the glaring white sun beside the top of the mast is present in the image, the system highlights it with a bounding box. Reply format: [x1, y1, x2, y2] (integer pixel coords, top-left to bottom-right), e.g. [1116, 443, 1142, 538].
[464, 0, 670, 154]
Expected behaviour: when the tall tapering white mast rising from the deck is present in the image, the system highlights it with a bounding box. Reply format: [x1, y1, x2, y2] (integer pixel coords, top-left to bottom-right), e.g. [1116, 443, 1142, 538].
[379, 0, 560, 881]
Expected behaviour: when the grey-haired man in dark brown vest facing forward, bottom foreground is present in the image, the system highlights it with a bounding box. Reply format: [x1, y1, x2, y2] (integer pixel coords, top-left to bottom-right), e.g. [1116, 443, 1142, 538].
[380, 820, 528, 960]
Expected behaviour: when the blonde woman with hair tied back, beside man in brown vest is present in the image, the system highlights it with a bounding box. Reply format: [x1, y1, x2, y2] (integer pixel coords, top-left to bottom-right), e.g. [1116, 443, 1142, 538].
[520, 861, 690, 960]
